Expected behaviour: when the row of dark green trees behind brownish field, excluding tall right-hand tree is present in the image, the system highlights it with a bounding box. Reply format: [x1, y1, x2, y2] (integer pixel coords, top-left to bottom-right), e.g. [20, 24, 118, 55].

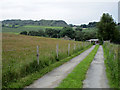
[20, 27, 97, 41]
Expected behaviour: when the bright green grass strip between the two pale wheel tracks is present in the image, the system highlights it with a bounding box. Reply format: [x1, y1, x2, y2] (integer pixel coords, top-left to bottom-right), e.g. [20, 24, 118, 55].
[57, 45, 99, 88]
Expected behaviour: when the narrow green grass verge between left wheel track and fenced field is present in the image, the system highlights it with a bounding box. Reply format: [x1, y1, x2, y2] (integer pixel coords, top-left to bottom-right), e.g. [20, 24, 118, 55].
[3, 45, 92, 88]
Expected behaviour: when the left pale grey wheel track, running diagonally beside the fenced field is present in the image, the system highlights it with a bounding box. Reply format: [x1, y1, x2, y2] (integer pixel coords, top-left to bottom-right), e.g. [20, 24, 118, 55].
[25, 46, 95, 88]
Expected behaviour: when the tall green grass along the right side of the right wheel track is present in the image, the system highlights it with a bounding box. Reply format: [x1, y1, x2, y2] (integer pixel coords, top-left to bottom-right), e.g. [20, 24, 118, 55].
[103, 42, 120, 88]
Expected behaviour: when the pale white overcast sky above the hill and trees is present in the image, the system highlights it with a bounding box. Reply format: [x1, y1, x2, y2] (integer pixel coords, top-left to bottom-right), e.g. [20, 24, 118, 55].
[0, 0, 119, 24]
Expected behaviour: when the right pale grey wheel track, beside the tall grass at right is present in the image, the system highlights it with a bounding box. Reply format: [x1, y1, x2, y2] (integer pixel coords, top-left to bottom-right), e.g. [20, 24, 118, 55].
[83, 46, 109, 88]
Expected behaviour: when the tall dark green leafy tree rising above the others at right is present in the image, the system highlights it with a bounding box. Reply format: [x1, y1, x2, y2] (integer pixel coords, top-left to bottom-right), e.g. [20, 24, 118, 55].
[97, 13, 116, 41]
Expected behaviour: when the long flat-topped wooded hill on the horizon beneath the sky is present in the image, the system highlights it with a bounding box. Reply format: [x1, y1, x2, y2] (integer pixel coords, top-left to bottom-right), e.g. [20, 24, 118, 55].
[2, 19, 68, 27]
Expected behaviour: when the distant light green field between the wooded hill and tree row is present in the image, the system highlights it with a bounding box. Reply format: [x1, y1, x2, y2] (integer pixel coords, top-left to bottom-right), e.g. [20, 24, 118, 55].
[2, 25, 63, 33]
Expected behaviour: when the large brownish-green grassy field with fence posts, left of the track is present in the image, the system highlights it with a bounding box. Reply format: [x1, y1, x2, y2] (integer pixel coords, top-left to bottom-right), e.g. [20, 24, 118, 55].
[2, 33, 90, 87]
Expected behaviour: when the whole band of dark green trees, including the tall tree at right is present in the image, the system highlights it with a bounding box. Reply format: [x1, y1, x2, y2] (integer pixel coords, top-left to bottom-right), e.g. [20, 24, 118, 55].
[20, 13, 120, 44]
